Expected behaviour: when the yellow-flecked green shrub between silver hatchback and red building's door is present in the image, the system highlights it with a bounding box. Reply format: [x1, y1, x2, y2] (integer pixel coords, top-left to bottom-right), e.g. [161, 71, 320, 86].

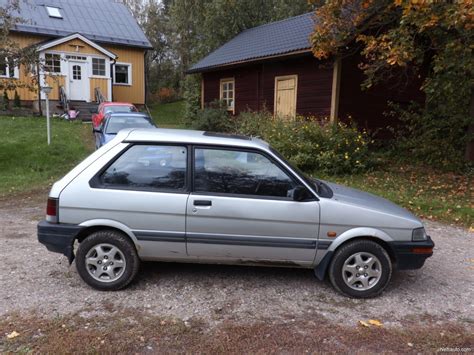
[234, 113, 371, 174]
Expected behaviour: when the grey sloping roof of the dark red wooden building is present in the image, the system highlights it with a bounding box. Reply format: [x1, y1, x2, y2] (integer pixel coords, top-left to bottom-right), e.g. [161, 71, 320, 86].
[188, 12, 314, 73]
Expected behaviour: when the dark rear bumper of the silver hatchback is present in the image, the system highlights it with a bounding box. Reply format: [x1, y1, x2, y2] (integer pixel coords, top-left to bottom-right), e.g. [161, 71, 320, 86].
[38, 221, 83, 263]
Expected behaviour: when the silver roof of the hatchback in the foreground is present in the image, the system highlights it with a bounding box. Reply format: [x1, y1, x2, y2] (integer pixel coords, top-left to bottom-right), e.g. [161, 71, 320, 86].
[122, 128, 269, 149]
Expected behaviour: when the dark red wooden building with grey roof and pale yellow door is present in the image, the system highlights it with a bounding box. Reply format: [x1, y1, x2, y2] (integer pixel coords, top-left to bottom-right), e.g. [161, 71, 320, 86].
[188, 13, 421, 134]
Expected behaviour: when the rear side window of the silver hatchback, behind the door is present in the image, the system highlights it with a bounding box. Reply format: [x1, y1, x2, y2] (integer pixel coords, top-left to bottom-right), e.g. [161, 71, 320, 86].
[98, 145, 187, 190]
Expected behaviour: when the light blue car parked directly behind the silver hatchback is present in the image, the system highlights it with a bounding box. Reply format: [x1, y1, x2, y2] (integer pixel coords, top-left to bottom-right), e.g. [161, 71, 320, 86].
[93, 112, 156, 149]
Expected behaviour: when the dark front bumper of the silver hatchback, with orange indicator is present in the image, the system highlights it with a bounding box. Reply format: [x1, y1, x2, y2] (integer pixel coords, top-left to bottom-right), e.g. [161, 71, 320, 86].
[390, 237, 435, 270]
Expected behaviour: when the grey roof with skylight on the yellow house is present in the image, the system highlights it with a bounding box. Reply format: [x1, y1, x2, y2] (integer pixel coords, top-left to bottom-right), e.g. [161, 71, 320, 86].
[0, 0, 151, 48]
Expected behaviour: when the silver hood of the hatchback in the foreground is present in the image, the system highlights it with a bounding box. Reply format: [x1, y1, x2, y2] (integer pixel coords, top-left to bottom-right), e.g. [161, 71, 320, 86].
[324, 181, 423, 228]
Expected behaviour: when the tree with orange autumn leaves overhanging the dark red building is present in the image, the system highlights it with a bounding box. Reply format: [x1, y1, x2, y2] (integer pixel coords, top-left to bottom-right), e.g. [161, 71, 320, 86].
[312, 0, 474, 165]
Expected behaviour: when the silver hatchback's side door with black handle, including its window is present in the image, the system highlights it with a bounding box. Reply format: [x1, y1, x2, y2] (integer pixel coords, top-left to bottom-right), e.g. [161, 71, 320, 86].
[186, 147, 319, 264]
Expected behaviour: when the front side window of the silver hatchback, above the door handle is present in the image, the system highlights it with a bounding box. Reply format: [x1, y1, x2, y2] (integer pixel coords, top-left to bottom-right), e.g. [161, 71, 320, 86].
[194, 148, 296, 198]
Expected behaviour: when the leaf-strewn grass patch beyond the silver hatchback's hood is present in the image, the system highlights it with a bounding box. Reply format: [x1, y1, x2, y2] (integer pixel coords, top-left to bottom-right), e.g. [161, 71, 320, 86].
[313, 162, 474, 228]
